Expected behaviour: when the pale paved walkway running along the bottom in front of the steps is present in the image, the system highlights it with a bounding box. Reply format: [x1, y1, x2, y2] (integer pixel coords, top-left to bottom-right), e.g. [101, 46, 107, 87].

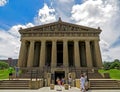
[0, 86, 120, 92]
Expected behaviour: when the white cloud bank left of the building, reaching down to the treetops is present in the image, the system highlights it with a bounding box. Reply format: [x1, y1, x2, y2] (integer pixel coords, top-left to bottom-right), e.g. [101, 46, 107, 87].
[0, 23, 34, 59]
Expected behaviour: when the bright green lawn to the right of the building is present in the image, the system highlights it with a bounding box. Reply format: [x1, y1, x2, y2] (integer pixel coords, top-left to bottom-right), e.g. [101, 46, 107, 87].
[99, 69, 120, 79]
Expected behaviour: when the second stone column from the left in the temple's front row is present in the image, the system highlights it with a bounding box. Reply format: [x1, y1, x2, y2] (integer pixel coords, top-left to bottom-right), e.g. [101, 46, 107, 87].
[27, 40, 34, 67]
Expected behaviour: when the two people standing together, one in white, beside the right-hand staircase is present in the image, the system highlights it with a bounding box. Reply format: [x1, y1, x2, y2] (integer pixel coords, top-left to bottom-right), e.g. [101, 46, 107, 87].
[80, 73, 88, 92]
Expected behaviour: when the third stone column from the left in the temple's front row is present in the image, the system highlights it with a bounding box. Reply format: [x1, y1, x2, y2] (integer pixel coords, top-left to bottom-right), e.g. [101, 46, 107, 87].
[39, 40, 46, 68]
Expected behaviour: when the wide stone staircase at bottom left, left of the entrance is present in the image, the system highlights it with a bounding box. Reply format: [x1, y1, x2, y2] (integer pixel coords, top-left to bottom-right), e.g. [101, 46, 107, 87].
[0, 80, 30, 89]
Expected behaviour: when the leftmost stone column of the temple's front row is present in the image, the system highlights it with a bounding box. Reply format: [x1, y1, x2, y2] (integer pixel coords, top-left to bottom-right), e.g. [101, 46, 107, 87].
[18, 40, 27, 67]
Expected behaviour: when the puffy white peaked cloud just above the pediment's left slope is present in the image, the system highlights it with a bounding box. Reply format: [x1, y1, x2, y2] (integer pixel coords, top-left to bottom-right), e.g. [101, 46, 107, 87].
[35, 4, 56, 24]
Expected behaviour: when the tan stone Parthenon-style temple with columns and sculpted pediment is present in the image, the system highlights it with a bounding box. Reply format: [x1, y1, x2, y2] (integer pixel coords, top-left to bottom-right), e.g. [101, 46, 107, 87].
[18, 18, 102, 82]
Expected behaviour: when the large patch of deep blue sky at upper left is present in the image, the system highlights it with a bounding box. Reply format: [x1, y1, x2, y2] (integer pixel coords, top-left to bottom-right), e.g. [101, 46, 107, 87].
[0, 0, 43, 28]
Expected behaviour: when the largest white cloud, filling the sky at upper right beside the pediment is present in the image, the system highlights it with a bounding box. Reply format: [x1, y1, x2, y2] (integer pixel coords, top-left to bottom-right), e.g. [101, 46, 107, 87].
[71, 0, 120, 60]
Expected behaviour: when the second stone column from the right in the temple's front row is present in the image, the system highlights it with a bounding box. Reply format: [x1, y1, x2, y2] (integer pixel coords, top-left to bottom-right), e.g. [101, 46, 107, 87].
[85, 40, 93, 67]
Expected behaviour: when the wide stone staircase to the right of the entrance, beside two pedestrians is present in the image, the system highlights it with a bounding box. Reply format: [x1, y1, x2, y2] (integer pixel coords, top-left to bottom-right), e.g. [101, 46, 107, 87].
[90, 79, 120, 89]
